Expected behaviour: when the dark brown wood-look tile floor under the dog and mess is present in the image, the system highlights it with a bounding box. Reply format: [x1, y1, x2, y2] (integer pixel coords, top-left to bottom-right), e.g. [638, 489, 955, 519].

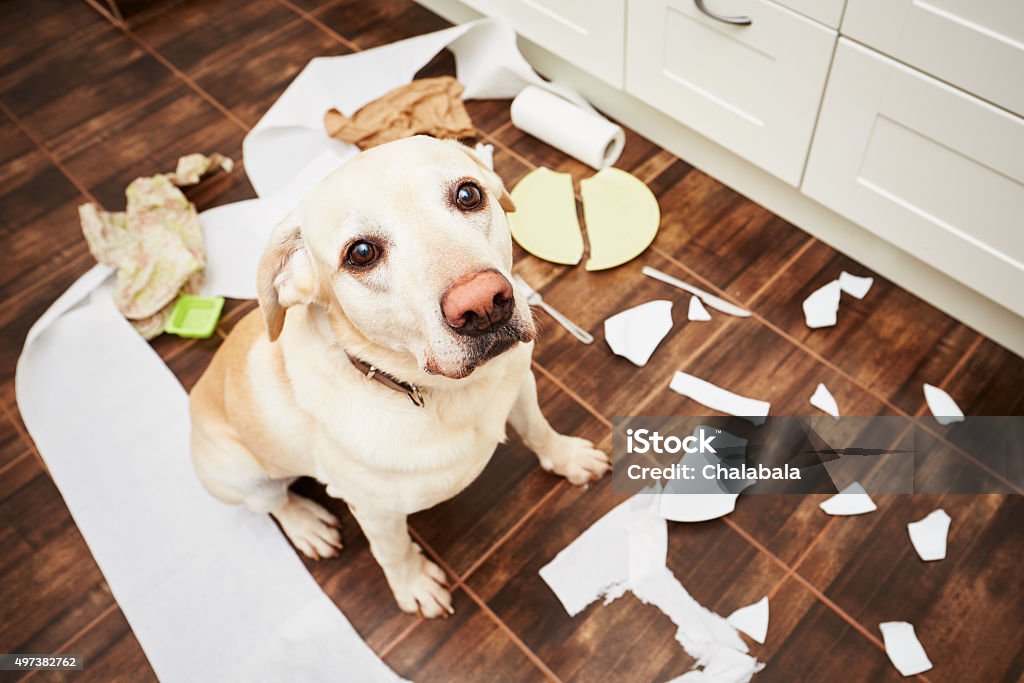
[0, 0, 1024, 683]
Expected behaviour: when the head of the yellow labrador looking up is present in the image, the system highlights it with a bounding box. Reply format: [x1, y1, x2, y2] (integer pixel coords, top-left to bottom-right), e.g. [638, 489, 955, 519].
[259, 136, 535, 379]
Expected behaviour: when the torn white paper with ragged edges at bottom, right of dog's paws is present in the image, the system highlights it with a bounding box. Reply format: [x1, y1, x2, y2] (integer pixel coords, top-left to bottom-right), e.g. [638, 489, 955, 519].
[540, 494, 764, 683]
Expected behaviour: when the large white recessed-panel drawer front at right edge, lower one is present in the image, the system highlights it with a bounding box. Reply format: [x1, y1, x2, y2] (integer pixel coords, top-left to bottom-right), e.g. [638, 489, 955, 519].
[803, 39, 1024, 315]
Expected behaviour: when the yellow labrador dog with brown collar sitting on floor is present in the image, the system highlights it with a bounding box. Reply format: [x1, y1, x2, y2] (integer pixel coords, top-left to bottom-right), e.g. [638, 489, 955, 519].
[190, 136, 608, 616]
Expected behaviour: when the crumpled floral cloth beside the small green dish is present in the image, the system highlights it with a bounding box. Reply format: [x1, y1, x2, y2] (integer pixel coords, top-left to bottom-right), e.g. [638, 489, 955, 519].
[78, 154, 233, 339]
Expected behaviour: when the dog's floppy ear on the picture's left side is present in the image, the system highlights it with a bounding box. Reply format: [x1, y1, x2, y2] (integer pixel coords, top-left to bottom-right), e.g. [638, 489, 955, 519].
[257, 211, 316, 341]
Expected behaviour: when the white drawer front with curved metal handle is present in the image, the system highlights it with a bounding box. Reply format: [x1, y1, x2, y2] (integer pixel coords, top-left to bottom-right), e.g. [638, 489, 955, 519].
[626, 0, 836, 185]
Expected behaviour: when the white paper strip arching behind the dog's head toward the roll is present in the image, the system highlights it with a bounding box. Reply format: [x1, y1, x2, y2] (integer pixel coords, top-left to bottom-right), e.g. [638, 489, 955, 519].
[242, 18, 613, 197]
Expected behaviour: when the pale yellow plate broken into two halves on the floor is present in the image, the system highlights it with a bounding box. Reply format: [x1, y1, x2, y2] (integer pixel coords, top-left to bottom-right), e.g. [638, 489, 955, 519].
[509, 167, 662, 270]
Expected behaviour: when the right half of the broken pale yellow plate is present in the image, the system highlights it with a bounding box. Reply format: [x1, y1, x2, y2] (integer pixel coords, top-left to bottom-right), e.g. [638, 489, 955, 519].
[581, 168, 662, 270]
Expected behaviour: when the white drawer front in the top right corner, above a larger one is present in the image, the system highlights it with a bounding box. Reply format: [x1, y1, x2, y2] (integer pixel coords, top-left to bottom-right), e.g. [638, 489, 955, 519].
[843, 0, 1024, 115]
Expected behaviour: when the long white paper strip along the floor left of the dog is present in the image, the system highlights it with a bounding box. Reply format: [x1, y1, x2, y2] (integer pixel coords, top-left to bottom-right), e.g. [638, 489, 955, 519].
[16, 274, 400, 681]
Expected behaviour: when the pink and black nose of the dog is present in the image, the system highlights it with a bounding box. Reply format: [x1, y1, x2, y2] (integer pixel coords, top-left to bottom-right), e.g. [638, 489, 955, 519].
[441, 270, 515, 336]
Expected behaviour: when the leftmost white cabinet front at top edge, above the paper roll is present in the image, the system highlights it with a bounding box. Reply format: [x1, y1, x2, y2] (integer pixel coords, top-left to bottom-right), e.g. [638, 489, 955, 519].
[465, 0, 626, 88]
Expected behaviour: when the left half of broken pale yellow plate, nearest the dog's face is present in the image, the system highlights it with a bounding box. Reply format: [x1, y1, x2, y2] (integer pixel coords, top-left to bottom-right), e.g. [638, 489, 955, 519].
[508, 167, 583, 265]
